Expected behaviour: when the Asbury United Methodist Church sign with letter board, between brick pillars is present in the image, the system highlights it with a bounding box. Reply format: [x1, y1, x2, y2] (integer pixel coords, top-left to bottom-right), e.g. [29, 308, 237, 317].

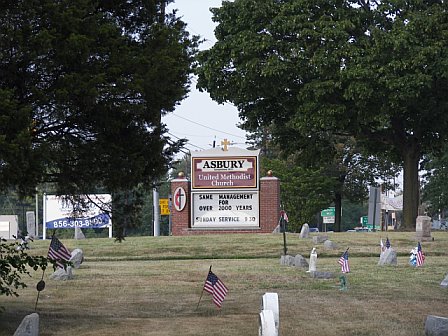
[191, 146, 260, 229]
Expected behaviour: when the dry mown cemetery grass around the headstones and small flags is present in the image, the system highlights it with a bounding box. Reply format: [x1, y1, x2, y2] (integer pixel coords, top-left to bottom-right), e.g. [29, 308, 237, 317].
[0, 232, 448, 336]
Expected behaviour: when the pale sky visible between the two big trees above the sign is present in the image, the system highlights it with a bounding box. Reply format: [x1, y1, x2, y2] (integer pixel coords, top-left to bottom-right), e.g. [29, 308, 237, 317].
[162, 0, 246, 152]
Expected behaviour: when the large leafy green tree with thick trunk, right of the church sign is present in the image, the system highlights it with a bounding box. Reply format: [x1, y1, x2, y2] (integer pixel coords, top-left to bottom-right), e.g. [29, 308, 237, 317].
[197, 0, 448, 229]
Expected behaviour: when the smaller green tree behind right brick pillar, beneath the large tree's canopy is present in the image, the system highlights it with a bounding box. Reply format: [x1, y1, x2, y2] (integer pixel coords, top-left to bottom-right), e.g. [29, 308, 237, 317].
[265, 134, 397, 231]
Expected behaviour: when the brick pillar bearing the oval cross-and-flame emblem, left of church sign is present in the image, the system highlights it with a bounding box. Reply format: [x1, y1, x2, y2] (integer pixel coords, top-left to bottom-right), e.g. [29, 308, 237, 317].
[171, 173, 191, 236]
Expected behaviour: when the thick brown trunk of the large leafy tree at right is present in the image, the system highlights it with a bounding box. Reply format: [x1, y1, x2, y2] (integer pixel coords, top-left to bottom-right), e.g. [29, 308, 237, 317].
[400, 144, 421, 231]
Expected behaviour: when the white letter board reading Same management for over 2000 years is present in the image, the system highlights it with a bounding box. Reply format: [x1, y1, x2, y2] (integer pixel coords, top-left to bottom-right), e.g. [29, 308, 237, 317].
[192, 191, 259, 229]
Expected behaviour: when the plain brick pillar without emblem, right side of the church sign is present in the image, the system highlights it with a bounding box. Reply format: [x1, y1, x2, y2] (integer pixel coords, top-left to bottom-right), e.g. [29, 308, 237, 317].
[260, 171, 280, 233]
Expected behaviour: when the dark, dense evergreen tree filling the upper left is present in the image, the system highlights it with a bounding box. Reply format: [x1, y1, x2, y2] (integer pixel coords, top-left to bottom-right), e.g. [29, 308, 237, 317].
[0, 0, 198, 239]
